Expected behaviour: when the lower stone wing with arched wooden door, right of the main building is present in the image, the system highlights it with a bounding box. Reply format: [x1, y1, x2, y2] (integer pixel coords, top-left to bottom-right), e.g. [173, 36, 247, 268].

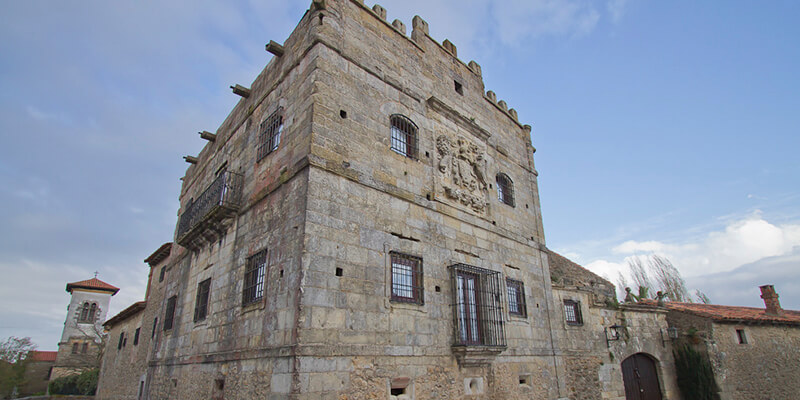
[549, 251, 680, 400]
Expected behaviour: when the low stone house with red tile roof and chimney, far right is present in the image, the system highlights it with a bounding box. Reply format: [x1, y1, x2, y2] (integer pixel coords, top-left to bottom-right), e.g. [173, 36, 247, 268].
[665, 285, 800, 400]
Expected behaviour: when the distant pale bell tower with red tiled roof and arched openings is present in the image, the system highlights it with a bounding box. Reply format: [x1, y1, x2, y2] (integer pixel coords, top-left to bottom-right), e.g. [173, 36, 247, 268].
[51, 276, 119, 379]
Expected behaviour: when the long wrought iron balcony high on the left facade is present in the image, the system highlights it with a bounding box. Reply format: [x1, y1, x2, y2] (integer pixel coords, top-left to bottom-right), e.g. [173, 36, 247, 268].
[177, 171, 244, 249]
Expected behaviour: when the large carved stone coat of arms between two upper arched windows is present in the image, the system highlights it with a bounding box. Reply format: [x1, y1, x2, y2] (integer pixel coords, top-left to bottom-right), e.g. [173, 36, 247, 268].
[436, 135, 487, 213]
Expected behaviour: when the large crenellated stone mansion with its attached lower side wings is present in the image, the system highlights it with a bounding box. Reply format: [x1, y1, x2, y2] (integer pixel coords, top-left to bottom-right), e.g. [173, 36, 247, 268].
[98, 0, 674, 399]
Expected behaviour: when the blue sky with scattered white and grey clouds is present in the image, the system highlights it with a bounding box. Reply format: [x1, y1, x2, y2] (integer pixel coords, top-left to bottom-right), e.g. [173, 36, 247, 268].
[0, 0, 800, 349]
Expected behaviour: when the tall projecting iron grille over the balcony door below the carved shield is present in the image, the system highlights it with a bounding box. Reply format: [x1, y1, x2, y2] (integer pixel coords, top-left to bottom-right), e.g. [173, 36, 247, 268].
[450, 264, 506, 347]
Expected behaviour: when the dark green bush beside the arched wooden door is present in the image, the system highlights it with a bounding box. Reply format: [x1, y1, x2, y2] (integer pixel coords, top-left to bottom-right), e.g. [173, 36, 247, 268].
[673, 344, 717, 400]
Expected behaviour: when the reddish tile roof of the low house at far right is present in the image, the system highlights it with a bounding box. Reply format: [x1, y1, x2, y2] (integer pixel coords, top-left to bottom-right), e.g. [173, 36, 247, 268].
[665, 301, 800, 325]
